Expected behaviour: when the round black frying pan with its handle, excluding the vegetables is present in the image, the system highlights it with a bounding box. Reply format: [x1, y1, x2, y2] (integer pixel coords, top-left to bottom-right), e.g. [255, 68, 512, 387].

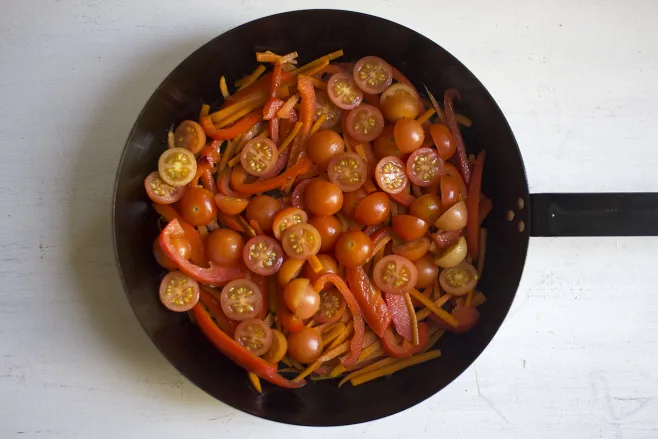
[114, 10, 658, 426]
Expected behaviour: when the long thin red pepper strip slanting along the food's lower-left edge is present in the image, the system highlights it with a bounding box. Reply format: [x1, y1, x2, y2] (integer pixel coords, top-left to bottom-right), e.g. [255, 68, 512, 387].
[192, 303, 306, 389]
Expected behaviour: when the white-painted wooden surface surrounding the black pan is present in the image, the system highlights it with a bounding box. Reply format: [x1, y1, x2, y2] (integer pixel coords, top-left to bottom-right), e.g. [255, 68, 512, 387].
[0, 0, 658, 439]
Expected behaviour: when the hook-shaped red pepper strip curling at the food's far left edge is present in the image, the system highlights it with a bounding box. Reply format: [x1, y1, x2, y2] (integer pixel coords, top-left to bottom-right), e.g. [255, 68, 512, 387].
[158, 220, 246, 286]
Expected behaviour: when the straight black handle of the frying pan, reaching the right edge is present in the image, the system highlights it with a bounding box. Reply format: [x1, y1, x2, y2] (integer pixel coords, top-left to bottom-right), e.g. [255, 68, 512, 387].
[530, 193, 658, 236]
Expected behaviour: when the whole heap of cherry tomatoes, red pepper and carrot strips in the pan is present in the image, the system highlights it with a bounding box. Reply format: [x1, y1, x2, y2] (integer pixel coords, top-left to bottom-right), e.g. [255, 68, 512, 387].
[144, 51, 492, 391]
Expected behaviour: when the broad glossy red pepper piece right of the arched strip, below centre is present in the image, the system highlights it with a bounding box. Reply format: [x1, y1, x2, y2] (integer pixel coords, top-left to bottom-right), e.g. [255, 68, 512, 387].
[345, 267, 390, 337]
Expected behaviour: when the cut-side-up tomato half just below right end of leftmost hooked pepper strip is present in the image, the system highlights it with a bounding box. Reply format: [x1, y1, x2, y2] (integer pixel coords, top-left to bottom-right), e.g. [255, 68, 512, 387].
[220, 279, 263, 321]
